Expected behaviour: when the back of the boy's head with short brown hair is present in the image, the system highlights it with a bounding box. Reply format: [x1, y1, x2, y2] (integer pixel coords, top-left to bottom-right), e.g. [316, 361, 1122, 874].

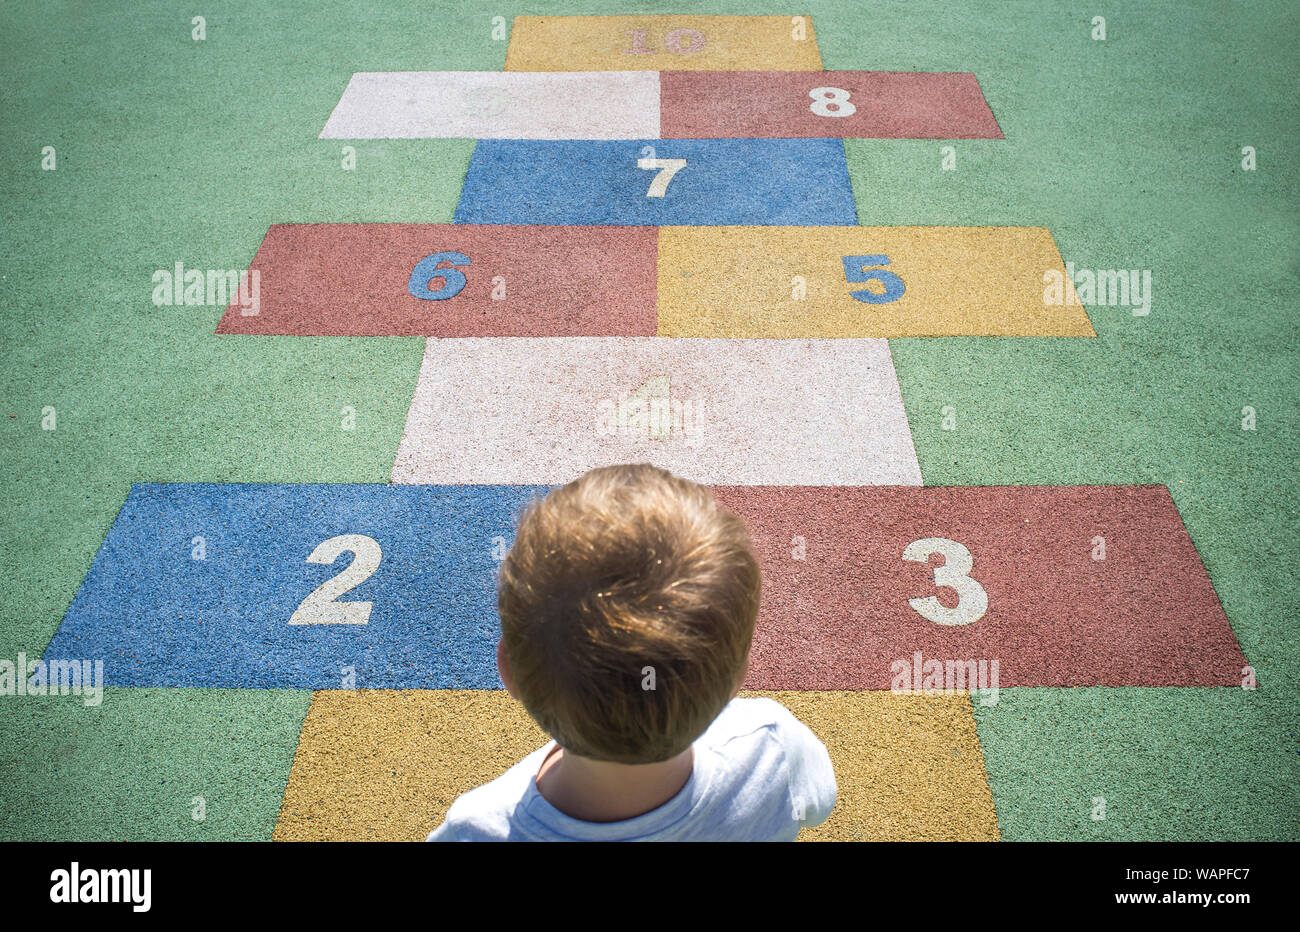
[498, 464, 761, 764]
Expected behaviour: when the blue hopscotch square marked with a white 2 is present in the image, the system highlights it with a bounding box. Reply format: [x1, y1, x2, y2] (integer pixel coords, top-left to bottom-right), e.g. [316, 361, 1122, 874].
[44, 484, 547, 689]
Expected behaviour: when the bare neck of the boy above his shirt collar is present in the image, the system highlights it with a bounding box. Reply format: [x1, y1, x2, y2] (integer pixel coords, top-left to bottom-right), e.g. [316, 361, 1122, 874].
[537, 746, 696, 822]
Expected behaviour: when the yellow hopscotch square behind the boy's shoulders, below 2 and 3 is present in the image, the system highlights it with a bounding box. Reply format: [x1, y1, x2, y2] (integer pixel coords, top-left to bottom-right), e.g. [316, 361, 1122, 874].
[274, 689, 998, 841]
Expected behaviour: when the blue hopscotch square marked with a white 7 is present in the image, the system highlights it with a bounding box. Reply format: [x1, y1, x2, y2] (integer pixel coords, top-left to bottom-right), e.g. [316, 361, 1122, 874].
[456, 139, 858, 226]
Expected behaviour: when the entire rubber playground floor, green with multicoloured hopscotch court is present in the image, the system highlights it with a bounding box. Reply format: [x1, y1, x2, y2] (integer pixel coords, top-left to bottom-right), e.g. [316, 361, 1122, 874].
[0, 0, 1300, 841]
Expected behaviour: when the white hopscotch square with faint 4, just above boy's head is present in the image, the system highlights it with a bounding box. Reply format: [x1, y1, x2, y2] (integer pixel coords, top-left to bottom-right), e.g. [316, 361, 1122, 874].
[393, 337, 922, 485]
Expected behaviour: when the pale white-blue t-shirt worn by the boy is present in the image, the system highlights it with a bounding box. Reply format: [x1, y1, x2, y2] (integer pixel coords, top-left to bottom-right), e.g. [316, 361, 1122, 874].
[428, 698, 836, 841]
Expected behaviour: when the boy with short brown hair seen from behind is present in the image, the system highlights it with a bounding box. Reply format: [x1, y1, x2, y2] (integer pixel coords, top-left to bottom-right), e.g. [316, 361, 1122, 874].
[428, 465, 836, 841]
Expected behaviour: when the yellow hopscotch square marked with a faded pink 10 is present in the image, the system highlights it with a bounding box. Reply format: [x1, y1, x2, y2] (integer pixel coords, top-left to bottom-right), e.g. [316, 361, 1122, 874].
[506, 16, 822, 71]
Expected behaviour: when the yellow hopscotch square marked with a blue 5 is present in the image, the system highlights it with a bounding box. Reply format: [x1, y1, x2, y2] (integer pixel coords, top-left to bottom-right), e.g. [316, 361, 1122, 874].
[658, 226, 1097, 338]
